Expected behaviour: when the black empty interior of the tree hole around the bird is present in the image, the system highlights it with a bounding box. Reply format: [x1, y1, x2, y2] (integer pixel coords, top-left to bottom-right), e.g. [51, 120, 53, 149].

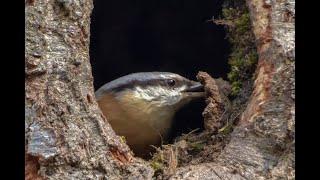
[90, 0, 230, 148]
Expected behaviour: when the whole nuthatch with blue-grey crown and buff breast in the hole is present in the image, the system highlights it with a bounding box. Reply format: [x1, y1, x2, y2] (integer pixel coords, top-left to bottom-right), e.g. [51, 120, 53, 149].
[95, 72, 204, 156]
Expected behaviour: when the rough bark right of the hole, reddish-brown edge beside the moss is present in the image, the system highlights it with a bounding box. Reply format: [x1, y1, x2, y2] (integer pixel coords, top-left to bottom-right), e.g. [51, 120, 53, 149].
[171, 0, 295, 179]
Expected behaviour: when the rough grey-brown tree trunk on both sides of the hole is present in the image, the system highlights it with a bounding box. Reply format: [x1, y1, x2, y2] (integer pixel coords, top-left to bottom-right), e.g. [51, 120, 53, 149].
[25, 0, 295, 179]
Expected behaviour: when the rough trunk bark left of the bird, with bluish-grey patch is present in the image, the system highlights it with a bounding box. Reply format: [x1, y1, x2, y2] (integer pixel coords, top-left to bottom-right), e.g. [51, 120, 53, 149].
[25, 0, 153, 179]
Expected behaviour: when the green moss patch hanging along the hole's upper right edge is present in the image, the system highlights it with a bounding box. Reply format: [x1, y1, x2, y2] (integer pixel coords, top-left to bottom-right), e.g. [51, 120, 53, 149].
[213, 0, 258, 96]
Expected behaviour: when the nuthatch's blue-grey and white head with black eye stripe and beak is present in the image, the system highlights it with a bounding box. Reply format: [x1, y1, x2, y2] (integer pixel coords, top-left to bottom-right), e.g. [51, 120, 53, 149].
[96, 72, 204, 111]
